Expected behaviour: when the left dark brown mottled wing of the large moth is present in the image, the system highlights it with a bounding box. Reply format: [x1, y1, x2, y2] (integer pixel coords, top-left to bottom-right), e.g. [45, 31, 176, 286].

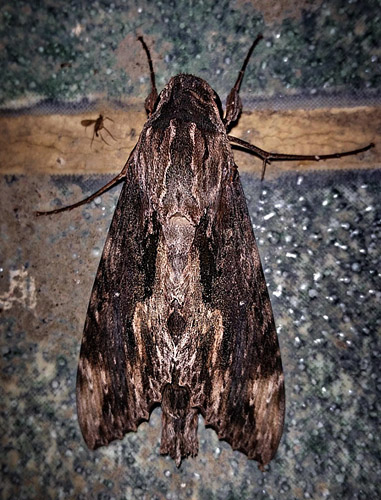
[77, 165, 166, 449]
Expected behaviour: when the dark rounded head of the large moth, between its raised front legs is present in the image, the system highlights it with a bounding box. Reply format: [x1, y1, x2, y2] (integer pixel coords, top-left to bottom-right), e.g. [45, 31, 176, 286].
[151, 74, 222, 129]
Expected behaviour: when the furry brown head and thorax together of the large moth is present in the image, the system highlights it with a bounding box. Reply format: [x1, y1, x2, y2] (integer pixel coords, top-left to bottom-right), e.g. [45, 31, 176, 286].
[136, 75, 234, 226]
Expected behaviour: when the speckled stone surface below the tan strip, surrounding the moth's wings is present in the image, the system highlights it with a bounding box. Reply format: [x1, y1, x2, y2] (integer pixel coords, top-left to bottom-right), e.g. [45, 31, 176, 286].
[0, 167, 381, 500]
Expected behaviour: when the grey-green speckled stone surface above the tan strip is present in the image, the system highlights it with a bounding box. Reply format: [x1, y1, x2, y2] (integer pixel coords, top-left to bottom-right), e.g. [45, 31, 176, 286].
[0, 0, 381, 111]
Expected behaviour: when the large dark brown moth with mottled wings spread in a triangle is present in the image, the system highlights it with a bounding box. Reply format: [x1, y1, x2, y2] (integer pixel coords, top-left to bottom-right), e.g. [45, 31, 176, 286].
[38, 36, 372, 468]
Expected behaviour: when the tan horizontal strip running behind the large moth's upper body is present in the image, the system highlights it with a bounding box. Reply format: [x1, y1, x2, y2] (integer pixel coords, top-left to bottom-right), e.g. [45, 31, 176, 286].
[0, 106, 381, 177]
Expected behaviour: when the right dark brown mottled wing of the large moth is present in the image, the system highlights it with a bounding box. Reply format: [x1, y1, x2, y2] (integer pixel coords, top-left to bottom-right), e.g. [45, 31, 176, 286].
[191, 174, 285, 465]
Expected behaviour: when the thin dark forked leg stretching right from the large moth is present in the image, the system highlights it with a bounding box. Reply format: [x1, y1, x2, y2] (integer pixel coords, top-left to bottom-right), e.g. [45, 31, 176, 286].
[228, 135, 374, 180]
